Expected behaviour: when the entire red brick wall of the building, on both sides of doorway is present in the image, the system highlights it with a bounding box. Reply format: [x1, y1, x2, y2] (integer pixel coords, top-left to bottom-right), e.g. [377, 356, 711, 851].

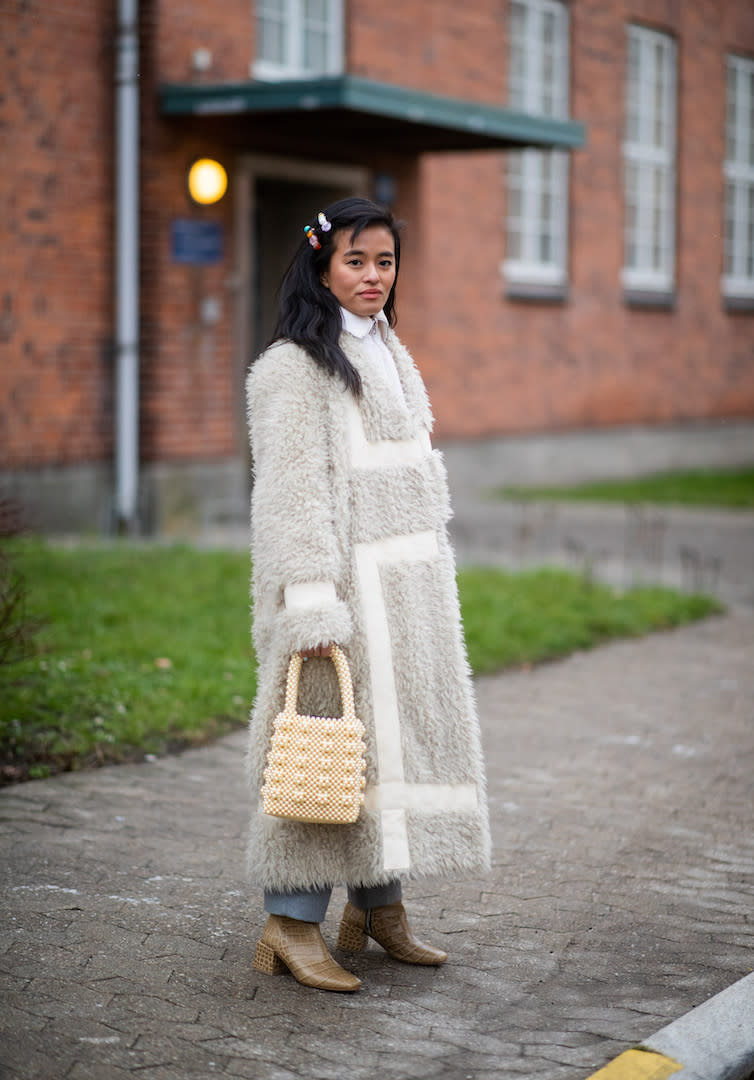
[0, 0, 754, 477]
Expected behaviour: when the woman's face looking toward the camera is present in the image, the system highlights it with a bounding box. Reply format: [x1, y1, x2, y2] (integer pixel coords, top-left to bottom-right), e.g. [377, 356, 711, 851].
[321, 225, 395, 315]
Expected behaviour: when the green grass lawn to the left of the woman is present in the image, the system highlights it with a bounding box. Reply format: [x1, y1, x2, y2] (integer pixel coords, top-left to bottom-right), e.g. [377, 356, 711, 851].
[0, 543, 255, 775]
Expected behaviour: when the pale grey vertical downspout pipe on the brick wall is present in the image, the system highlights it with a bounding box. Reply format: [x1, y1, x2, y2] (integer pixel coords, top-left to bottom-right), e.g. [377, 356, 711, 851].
[115, 0, 139, 534]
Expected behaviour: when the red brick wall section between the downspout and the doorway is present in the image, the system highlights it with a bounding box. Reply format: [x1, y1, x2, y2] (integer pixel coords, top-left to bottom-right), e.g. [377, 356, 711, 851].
[140, 0, 237, 461]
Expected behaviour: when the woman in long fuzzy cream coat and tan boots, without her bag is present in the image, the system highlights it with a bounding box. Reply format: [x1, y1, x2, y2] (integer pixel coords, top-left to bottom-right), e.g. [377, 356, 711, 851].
[247, 198, 489, 990]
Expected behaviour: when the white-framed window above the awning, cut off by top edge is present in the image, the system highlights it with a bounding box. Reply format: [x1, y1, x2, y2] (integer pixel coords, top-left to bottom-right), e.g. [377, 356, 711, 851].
[252, 0, 344, 80]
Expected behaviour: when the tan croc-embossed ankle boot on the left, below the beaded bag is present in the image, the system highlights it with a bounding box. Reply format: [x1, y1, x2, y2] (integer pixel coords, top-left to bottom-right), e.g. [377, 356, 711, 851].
[254, 915, 361, 993]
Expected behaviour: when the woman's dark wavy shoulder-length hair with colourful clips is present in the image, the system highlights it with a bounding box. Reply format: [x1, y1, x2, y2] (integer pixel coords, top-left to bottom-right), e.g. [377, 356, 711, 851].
[262, 197, 401, 396]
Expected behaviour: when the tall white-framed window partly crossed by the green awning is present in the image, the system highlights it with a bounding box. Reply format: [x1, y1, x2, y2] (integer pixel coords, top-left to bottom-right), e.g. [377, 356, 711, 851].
[502, 0, 568, 286]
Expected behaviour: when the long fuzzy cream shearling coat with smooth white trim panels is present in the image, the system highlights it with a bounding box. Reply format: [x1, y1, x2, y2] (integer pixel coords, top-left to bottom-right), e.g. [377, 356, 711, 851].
[246, 330, 489, 890]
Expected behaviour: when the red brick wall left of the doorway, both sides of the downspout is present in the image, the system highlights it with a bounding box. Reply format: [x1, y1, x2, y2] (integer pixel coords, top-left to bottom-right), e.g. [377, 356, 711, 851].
[0, 0, 249, 469]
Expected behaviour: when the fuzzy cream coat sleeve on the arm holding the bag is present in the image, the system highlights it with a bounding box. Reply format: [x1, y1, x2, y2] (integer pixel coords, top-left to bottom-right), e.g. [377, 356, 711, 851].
[246, 346, 351, 652]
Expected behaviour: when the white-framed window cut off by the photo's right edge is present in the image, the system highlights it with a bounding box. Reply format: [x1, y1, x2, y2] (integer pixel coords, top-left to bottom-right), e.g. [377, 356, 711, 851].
[723, 56, 754, 297]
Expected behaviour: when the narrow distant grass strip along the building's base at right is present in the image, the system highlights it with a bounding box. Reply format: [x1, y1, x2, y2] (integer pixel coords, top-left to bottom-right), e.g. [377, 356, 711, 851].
[496, 469, 754, 510]
